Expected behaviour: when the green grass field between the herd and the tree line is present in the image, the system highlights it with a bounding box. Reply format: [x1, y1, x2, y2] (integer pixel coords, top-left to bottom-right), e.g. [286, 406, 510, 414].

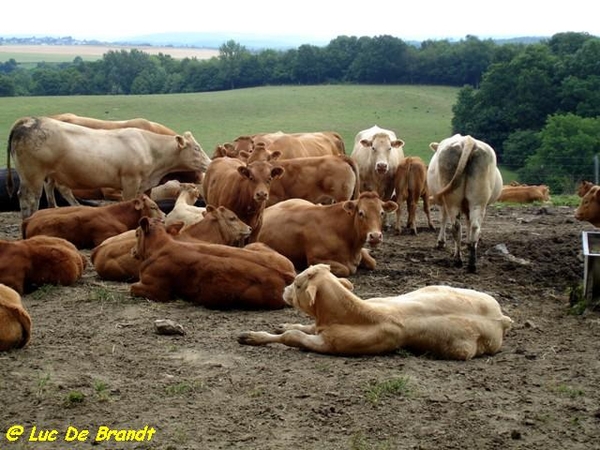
[0, 86, 458, 167]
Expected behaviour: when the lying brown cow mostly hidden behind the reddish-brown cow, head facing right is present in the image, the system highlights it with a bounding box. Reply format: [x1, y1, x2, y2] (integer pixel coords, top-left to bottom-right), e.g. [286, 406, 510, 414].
[91, 205, 252, 281]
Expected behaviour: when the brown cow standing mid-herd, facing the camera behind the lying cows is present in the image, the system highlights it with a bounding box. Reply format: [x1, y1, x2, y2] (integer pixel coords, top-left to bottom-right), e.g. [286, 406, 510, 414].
[202, 157, 284, 242]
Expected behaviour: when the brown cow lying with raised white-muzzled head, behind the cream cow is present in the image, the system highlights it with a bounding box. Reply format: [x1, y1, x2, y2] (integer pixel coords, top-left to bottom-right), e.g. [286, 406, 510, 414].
[258, 191, 398, 276]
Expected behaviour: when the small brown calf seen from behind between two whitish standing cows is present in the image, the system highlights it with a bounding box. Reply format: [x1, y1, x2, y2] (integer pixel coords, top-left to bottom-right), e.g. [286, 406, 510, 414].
[394, 156, 435, 235]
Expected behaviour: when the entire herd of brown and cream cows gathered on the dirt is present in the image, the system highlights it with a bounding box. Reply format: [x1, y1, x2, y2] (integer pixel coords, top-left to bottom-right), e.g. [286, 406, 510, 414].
[0, 114, 572, 360]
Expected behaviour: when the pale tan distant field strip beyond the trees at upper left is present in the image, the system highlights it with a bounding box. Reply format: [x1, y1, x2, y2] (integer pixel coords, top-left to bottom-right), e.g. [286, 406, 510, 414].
[0, 45, 219, 64]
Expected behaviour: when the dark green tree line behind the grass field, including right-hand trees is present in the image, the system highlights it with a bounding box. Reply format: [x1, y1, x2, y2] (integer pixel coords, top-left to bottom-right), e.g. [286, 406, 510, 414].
[0, 32, 600, 192]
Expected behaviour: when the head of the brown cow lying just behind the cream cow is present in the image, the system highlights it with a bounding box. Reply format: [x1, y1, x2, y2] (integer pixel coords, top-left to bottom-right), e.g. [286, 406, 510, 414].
[343, 191, 398, 247]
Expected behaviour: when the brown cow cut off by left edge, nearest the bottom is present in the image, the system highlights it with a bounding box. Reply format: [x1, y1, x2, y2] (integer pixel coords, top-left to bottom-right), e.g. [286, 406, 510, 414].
[0, 284, 31, 352]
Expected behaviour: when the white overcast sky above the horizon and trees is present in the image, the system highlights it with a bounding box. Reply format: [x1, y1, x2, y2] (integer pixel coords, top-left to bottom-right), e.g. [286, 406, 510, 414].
[0, 0, 600, 43]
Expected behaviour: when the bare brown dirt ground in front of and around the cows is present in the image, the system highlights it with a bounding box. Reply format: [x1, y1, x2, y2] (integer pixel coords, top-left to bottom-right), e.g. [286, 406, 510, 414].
[0, 206, 600, 450]
